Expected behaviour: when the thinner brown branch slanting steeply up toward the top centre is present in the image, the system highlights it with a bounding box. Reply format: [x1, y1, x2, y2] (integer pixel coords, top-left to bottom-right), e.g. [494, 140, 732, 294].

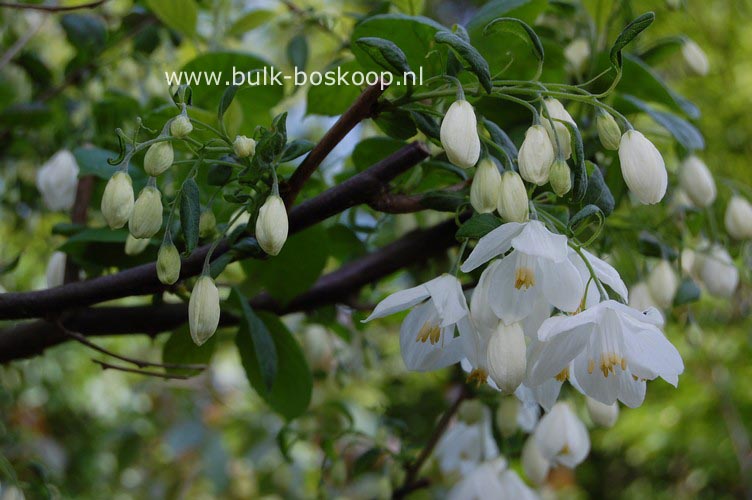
[280, 82, 387, 210]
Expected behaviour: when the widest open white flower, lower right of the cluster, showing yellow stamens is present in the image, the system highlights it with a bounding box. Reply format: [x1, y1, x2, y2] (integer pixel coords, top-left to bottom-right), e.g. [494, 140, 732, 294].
[528, 300, 684, 408]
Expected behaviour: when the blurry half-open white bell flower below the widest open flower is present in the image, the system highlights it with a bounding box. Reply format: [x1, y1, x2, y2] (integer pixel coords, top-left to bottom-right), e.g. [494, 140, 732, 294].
[533, 402, 590, 469]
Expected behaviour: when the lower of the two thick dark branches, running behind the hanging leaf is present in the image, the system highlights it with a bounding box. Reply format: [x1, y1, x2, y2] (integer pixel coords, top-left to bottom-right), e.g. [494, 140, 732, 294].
[0, 220, 457, 363]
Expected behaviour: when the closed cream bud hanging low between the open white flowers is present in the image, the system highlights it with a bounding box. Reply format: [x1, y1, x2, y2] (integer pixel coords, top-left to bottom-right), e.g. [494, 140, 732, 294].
[488, 321, 527, 394]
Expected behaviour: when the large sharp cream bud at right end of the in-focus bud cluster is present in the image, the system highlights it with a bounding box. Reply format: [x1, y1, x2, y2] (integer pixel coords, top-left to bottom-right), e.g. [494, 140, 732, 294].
[619, 130, 668, 205]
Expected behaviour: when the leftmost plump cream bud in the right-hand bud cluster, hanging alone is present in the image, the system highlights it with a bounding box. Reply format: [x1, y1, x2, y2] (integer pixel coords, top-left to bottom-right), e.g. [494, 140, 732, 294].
[439, 99, 480, 168]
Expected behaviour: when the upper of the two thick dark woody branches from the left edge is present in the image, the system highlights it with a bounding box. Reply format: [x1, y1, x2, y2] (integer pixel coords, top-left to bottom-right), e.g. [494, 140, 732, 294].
[0, 142, 428, 319]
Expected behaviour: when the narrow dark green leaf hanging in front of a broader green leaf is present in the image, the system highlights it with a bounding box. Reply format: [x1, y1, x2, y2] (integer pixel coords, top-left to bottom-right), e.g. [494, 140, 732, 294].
[231, 287, 277, 391]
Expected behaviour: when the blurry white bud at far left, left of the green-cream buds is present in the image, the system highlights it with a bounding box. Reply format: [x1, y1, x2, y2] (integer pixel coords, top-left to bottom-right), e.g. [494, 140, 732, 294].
[37, 149, 78, 211]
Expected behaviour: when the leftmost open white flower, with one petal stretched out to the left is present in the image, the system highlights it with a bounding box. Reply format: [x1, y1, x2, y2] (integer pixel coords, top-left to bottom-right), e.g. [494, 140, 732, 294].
[365, 274, 470, 371]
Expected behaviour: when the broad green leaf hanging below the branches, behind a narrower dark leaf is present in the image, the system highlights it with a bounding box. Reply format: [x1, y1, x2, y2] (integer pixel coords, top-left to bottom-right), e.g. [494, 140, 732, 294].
[235, 312, 313, 420]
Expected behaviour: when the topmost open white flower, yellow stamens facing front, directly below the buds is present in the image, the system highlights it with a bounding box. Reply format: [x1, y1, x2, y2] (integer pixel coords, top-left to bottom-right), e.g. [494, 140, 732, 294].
[462, 221, 585, 324]
